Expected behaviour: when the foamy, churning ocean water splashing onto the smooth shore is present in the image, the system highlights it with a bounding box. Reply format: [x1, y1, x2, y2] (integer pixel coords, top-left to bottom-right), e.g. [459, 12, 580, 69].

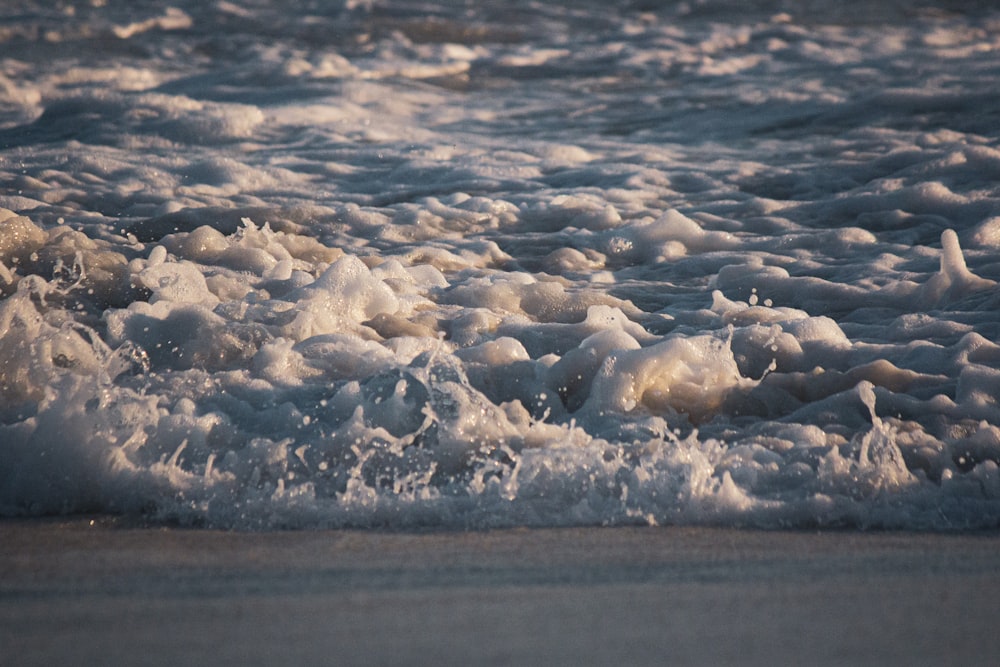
[0, 0, 1000, 530]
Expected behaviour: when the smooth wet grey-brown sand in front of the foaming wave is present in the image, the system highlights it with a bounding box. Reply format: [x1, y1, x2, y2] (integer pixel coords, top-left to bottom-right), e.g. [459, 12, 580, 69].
[0, 519, 1000, 665]
